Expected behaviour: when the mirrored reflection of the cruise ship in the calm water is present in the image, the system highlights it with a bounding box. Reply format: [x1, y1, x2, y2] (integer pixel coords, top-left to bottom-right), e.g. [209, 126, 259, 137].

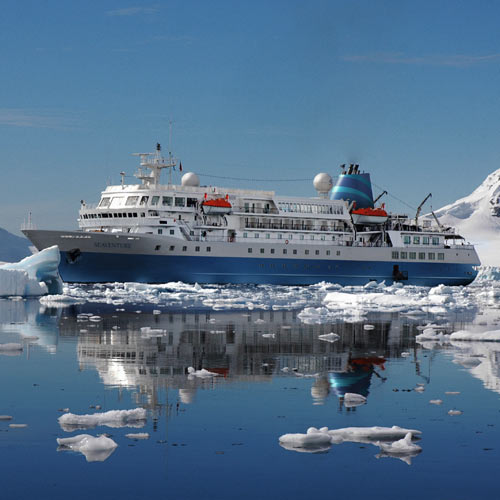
[51, 311, 430, 409]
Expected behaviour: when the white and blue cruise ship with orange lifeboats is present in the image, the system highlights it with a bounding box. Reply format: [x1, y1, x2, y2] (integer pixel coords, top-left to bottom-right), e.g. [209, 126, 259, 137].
[23, 144, 480, 286]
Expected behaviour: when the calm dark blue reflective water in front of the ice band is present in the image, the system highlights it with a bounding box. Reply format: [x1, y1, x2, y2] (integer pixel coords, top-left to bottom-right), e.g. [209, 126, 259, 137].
[0, 292, 500, 500]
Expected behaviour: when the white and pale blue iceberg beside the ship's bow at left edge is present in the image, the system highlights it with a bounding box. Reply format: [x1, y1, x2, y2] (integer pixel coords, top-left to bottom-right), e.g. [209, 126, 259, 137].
[0, 246, 63, 297]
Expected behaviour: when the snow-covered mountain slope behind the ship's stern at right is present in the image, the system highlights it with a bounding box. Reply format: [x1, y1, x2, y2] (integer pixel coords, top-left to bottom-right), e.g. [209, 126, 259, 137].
[435, 169, 500, 266]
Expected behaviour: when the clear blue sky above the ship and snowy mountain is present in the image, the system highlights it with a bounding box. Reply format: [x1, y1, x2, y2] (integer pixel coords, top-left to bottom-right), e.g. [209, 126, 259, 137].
[0, 0, 500, 234]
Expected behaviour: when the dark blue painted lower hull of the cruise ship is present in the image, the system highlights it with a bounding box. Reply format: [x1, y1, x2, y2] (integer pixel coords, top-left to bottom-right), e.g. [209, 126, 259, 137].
[59, 251, 477, 286]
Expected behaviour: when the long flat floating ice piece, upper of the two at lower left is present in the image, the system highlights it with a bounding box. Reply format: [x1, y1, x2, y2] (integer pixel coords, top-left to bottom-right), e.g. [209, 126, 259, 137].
[58, 408, 146, 432]
